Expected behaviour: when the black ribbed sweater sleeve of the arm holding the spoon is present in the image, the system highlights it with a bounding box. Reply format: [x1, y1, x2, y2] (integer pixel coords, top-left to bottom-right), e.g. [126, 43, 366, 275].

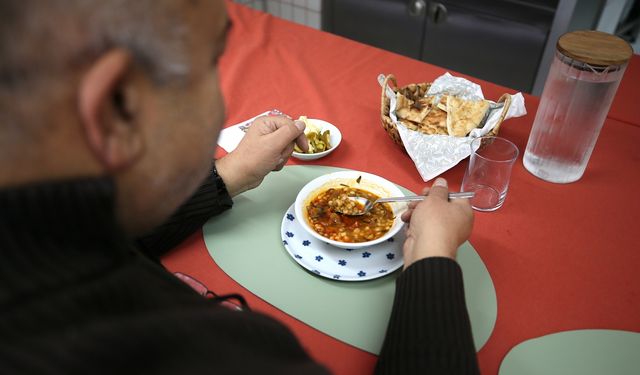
[375, 257, 479, 375]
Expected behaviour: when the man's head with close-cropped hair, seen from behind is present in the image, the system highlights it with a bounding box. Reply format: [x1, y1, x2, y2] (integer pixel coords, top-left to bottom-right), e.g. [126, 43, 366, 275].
[0, 0, 229, 232]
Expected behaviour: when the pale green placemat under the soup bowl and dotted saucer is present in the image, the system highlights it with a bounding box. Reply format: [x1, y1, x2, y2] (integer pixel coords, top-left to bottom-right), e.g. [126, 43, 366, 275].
[203, 166, 497, 354]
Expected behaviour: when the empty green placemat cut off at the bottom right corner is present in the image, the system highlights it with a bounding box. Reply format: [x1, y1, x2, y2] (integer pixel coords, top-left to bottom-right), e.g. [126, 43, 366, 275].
[500, 329, 640, 375]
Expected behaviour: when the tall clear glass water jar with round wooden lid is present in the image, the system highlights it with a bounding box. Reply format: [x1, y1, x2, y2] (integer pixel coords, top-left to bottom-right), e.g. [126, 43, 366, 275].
[523, 31, 633, 183]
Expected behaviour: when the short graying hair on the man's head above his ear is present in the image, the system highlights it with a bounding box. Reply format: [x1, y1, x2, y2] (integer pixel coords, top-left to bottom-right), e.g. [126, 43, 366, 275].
[0, 0, 190, 91]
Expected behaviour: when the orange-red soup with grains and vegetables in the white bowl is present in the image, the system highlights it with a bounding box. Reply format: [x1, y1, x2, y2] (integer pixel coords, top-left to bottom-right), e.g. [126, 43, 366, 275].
[307, 186, 395, 242]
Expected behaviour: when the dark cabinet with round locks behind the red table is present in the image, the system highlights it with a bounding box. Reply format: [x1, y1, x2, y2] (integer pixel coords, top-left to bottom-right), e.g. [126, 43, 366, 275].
[323, 0, 558, 92]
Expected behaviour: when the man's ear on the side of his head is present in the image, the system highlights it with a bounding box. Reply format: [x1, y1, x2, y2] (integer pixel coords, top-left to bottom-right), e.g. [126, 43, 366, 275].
[78, 49, 144, 172]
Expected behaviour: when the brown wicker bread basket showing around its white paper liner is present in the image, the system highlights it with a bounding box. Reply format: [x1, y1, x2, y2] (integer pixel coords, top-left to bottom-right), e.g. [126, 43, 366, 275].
[380, 74, 511, 148]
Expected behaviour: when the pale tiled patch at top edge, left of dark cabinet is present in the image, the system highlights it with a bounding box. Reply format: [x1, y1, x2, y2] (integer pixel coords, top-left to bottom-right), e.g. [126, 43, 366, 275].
[235, 0, 322, 29]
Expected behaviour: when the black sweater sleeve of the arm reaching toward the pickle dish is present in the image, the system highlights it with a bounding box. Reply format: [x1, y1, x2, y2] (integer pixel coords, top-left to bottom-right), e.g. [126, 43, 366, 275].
[136, 166, 233, 259]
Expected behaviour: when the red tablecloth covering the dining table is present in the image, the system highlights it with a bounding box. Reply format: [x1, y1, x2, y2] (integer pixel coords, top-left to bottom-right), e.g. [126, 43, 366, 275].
[162, 1, 640, 374]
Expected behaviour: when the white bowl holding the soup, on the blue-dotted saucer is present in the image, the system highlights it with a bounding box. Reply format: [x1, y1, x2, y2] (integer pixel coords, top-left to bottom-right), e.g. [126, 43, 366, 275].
[294, 171, 405, 249]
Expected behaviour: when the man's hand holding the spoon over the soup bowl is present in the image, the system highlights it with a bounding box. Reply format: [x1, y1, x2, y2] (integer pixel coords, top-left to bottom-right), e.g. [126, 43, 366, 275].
[401, 178, 473, 269]
